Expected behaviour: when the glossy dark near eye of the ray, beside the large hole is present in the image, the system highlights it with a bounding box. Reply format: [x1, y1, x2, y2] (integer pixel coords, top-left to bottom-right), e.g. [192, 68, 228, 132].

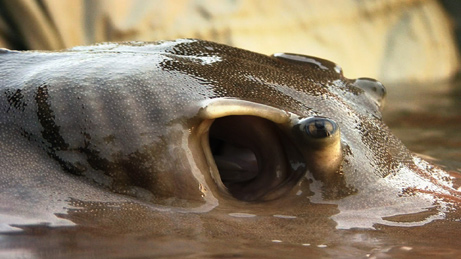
[300, 117, 338, 139]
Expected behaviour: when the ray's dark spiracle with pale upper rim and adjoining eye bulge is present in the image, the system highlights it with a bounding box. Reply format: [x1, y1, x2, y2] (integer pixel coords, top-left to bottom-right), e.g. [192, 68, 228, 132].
[198, 98, 344, 201]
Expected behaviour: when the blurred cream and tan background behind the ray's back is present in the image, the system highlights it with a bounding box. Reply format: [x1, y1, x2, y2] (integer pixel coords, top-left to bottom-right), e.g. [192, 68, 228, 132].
[0, 0, 461, 83]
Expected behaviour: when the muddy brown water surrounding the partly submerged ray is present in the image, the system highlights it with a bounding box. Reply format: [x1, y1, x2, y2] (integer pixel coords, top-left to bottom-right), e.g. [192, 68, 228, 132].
[0, 80, 461, 258]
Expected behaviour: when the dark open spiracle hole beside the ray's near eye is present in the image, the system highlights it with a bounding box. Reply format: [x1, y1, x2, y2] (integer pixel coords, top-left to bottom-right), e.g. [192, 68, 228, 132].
[204, 115, 305, 201]
